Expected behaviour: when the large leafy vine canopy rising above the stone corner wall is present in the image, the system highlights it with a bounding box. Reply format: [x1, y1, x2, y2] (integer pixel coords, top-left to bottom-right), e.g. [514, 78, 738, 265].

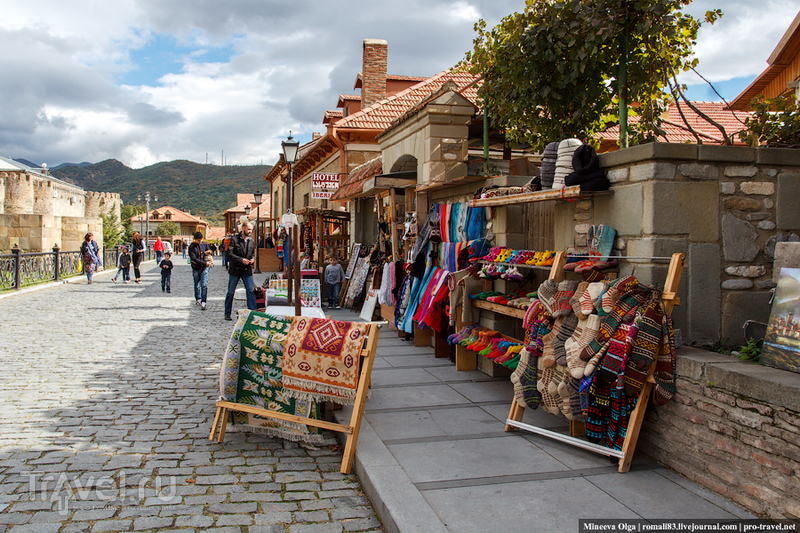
[463, 0, 722, 149]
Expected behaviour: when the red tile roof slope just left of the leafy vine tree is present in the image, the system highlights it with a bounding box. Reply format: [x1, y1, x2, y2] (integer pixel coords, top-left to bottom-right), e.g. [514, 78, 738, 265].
[334, 69, 478, 131]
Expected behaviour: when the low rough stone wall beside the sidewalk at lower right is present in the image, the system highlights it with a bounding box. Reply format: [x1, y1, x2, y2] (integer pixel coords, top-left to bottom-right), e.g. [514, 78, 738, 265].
[638, 348, 800, 520]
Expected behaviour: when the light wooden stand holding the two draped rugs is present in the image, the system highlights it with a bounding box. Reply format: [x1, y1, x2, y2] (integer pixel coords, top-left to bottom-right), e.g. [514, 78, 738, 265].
[208, 323, 380, 474]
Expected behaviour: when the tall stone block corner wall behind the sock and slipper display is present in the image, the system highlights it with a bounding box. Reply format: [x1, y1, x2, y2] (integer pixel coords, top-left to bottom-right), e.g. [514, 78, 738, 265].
[555, 143, 800, 345]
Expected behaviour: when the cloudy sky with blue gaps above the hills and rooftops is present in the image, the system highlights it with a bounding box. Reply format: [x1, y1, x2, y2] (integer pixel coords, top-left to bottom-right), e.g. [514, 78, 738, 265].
[0, 0, 798, 168]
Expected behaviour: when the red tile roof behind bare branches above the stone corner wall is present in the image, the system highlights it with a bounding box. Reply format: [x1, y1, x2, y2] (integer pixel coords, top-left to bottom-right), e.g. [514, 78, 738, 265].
[599, 102, 750, 144]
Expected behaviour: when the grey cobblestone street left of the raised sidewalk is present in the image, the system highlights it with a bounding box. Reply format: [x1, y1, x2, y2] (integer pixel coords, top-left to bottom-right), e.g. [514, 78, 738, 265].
[0, 255, 381, 533]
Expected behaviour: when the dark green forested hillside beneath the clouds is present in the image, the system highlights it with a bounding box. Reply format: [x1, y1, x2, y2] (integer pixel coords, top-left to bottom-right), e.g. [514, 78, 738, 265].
[52, 159, 272, 225]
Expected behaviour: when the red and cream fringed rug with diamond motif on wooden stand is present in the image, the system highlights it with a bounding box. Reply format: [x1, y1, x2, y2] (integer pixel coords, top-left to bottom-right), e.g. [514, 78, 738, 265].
[283, 317, 369, 405]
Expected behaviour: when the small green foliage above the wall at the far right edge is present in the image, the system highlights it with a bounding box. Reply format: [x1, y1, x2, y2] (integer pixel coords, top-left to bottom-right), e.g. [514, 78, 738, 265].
[739, 95, 800, 146]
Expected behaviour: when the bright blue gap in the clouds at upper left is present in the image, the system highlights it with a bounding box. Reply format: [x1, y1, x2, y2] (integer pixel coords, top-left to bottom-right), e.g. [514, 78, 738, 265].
[120, 34, 233, 87]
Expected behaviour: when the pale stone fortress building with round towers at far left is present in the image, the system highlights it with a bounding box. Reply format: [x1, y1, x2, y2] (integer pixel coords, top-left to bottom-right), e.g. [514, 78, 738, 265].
[0, 157, 122, 252]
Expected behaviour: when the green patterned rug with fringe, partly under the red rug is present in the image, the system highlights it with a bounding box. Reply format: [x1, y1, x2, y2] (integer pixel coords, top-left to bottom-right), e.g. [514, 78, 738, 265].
[220, 311, 322, 443]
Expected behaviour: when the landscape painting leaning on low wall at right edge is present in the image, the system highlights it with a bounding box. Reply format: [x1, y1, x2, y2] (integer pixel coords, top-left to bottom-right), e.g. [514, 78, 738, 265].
[761, 267, 800, 372]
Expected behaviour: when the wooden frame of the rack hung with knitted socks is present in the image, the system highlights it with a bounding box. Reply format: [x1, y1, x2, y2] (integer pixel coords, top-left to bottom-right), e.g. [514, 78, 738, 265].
[506, 252, 686, 473]
